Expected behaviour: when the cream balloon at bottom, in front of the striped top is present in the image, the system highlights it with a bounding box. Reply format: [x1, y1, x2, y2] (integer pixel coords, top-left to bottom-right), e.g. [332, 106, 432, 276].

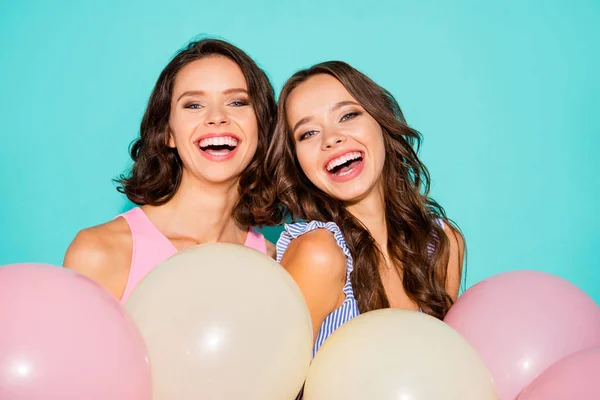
[304, 309, 498, 400]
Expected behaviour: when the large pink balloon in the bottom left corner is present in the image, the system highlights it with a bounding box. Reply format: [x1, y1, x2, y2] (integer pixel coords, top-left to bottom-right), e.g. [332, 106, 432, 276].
[0, 264, 151, 400]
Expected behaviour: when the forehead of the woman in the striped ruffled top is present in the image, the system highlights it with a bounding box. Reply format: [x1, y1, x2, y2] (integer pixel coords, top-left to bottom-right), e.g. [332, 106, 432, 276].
[286, 74, 356, 123]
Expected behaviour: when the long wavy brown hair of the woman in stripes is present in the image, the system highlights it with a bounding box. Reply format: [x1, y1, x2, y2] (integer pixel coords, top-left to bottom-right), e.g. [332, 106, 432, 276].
[256, 61, 462, 319]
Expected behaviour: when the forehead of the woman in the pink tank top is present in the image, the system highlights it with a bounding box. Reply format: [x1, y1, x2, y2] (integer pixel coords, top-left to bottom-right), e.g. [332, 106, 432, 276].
[173, 55, 248, 94]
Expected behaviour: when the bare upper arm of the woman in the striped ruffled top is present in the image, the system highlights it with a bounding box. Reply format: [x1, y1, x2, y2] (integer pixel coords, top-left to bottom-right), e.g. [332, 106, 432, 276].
[281, 229, 346, 340]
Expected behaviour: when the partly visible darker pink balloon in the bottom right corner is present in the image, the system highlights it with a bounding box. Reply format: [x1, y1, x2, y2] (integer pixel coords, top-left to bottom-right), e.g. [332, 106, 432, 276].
[518, 348, 600, 400]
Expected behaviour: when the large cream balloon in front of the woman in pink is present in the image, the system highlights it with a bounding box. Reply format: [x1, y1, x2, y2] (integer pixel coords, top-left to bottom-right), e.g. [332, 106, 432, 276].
[126, 243, 313, 400]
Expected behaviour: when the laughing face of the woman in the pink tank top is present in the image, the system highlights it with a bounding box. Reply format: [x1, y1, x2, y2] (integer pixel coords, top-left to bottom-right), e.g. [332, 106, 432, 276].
[169, 55, 258, 183]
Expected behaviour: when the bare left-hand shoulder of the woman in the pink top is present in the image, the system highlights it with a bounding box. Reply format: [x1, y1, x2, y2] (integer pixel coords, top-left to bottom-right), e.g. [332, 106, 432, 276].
[63, 218, 132, 297]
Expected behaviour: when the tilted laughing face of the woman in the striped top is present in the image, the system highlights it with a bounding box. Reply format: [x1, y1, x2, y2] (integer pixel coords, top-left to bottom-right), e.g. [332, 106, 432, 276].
[286, 74, 385, 202]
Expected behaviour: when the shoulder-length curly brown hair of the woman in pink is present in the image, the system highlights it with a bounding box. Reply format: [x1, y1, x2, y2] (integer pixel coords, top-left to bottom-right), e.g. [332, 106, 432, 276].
[115, 39, 277, 226]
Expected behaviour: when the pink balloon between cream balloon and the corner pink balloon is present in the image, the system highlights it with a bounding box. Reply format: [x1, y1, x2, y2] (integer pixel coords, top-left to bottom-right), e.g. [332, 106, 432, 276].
[444, 271, 600, 400]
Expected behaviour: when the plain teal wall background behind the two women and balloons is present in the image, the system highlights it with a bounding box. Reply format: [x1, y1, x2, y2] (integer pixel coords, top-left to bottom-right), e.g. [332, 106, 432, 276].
[0, 0, 600, 302]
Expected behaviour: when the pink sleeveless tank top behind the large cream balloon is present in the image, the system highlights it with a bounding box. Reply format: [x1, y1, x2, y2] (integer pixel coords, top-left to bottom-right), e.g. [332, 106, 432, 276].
[116, 207, 267, 303]
